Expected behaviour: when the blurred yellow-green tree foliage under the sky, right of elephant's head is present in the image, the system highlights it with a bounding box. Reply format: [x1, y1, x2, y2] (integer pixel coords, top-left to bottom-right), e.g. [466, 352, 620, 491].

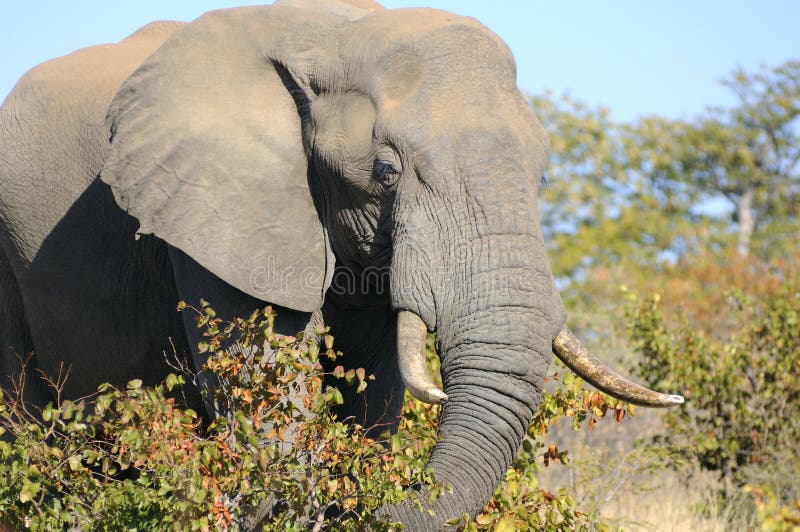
[532, 61, 800, 280]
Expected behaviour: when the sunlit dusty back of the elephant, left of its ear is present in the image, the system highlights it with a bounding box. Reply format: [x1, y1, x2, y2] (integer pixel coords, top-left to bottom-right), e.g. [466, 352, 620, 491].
[0, 22, 183, 263]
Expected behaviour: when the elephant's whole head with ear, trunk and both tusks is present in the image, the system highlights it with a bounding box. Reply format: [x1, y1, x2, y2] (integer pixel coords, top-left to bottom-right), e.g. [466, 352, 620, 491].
[101, 2, 679, 529]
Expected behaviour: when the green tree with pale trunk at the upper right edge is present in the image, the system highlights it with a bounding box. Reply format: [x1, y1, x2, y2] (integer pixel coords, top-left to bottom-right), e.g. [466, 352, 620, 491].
[627, 61, 800, 258]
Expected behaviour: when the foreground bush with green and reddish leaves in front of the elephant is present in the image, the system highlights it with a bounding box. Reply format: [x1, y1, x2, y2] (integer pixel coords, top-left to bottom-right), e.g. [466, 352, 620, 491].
[0, 303, 628, 530]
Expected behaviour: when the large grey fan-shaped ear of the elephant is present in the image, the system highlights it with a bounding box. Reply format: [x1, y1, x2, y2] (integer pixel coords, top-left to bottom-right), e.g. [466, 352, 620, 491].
[101, 6, 342, 311]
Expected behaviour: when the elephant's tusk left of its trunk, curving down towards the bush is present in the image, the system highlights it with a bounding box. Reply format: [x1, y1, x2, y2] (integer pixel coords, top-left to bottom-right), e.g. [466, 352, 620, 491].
[397, 310, 447, 404]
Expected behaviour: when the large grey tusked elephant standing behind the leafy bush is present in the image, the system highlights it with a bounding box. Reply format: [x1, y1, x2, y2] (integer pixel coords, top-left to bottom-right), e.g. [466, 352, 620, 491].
[0, 0, 682, 530]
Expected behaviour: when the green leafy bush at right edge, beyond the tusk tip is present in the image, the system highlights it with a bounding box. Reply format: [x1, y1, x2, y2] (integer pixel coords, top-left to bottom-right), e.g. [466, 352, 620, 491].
[628, 271, 800, 504]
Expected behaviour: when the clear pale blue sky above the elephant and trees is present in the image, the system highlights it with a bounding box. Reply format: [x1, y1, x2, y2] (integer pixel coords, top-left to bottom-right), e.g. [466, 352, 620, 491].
[0, 0, 800, 120]
